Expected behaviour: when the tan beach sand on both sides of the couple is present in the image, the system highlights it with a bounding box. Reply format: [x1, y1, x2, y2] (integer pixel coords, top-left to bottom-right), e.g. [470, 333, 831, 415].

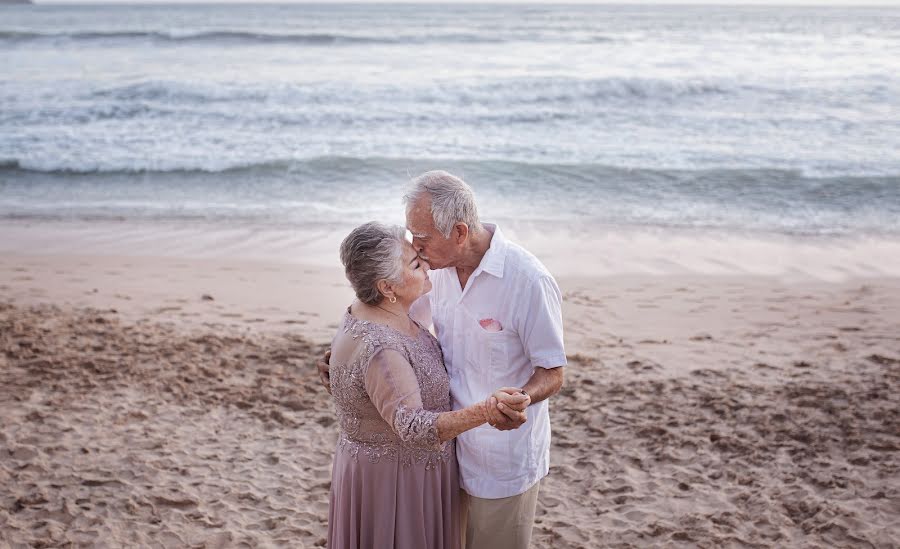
[0, 225, 900, 548]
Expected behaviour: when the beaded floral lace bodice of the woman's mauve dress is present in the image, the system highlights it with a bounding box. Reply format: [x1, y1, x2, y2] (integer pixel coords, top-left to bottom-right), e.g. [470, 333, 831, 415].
[330, 313, 454, 469]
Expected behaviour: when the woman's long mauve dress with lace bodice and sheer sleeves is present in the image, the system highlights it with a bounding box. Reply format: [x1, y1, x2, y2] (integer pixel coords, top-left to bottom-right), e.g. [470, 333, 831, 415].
[328, 311, 460, 549]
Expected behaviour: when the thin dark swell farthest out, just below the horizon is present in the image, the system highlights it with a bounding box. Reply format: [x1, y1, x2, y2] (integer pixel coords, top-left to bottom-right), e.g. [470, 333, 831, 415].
[0, 30, 613, 46]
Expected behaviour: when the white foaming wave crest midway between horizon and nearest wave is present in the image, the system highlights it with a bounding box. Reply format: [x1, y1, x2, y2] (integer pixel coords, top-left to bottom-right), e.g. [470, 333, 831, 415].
[0, 77, 732, 117]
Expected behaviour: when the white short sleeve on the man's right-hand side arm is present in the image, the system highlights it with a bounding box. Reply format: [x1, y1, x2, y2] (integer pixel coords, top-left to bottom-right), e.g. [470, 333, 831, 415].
[518, 275, 567, 368]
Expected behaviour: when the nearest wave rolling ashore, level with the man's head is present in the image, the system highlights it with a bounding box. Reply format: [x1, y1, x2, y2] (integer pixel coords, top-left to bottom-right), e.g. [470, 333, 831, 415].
[0, 156, 900, 236]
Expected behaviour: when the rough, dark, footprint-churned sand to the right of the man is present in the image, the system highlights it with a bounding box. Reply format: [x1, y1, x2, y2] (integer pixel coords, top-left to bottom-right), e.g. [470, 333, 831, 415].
[536, 355, 900, 548]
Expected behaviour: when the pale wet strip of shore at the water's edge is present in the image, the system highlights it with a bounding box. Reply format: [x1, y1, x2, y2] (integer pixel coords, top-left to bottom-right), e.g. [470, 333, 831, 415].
[0, 219, 900, 283]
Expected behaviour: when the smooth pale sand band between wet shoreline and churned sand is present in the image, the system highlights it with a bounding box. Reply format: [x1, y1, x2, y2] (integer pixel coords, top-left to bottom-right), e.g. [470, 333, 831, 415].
[0, 252, 900, 360]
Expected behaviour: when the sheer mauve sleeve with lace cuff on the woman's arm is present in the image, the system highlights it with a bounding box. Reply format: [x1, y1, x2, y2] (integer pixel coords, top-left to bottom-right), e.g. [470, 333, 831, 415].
[365, 349, 441, 450]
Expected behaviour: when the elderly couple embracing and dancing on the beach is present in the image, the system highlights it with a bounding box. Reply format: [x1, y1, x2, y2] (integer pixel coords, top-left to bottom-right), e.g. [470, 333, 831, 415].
[318, 171, 566, 549]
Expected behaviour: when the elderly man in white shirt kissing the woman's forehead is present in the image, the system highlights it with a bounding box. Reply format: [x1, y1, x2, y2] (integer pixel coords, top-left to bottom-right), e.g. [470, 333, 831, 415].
[319, 171, 566, 549]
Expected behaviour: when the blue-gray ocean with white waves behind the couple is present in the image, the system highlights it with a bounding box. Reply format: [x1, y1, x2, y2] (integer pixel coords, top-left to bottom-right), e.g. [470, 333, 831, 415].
[0, 4, 900, 239]
